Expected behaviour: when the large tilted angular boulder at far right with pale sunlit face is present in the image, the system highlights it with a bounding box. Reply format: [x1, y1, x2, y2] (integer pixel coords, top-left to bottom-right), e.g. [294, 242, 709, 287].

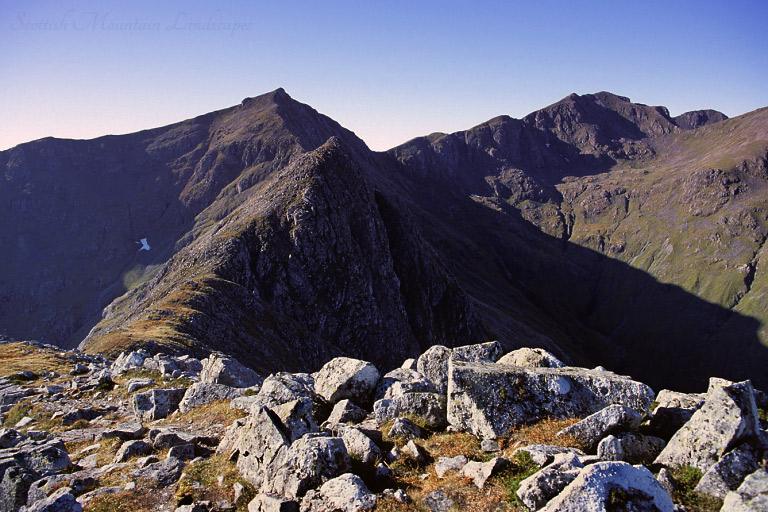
[656, 378, 760, 472]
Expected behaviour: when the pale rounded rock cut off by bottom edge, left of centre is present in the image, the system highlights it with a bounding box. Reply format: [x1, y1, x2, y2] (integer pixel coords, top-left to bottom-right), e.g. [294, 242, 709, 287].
[301, 473, 376, 512]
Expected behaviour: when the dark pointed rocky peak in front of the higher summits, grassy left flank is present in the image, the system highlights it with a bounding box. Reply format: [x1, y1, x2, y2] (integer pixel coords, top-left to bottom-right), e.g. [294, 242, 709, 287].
[82, 138, 483, 371]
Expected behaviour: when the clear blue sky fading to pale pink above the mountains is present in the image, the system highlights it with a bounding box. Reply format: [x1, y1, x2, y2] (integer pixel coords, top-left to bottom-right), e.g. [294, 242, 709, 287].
[0, 0, 768, 150]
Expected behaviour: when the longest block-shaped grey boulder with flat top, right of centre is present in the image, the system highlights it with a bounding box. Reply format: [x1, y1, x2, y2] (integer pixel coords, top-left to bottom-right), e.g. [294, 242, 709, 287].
[448, 360, 653, 439]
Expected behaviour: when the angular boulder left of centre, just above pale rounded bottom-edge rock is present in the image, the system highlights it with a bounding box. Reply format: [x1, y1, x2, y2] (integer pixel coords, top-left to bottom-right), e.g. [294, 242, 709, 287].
[268, 435, 351, 499]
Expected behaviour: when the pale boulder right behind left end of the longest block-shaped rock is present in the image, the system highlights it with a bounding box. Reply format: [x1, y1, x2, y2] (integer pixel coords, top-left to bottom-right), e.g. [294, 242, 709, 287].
[416, 341, 503, 395]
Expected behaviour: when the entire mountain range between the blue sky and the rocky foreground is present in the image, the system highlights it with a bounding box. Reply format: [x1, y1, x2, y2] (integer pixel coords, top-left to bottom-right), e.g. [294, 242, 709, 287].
[0, 89, 768, 391]
